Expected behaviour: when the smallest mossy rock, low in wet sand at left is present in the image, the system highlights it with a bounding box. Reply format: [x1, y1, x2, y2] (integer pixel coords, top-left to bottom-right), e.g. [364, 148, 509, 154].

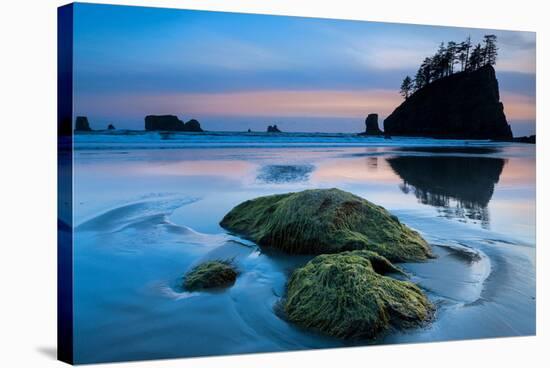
[183, 261, 237, 291]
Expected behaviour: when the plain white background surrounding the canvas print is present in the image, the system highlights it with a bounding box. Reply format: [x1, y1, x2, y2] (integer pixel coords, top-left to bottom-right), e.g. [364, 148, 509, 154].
[0, 0, 550, 368]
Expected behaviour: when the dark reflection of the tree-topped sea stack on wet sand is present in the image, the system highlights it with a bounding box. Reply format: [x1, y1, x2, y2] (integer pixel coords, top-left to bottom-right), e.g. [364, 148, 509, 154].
[386, 156, 506, 228]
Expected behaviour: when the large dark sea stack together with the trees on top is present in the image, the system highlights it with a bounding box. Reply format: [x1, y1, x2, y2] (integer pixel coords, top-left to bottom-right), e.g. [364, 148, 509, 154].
[390, 35, 512, 140]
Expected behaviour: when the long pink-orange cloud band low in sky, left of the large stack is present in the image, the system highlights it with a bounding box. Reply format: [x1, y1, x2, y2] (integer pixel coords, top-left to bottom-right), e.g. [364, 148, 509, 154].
[77, 90, 402, 117]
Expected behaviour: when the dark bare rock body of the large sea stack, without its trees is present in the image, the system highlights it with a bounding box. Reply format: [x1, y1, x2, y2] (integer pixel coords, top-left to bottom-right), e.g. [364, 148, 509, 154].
[384, 65, 512, 140]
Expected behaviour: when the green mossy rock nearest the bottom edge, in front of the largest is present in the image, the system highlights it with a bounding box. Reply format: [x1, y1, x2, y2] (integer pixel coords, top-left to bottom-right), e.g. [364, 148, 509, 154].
[284, 250, 434, 339]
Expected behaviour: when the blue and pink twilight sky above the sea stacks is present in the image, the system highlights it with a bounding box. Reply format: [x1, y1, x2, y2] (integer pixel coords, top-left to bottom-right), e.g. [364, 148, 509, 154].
[73, 4, 536, 135]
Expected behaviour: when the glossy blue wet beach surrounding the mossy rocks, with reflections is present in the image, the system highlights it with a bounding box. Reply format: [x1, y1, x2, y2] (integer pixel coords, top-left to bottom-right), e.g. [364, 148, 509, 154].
[74, 139, 535, 363]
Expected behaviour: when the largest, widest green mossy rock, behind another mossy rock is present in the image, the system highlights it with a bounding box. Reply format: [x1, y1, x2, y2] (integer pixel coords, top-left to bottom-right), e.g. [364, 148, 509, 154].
[220, 189, 432, 261]
